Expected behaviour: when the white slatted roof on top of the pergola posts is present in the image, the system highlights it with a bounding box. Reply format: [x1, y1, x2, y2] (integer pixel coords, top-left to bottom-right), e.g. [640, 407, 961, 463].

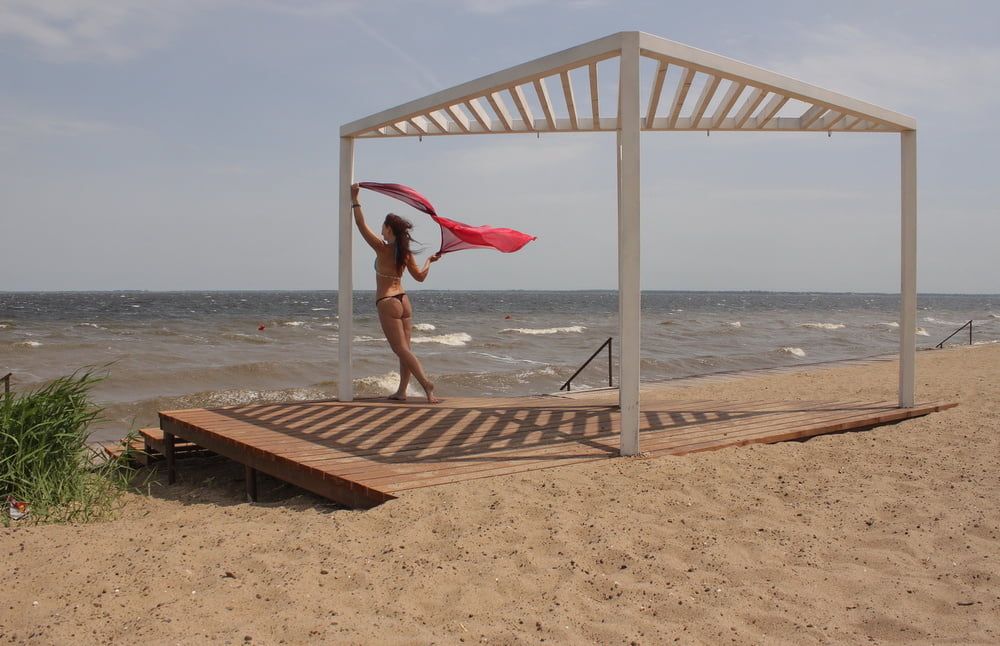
[340, 32, 917, 138]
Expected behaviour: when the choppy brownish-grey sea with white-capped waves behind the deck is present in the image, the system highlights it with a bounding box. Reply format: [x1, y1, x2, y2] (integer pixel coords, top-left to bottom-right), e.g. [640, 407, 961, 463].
[0, 290, 1000, 441]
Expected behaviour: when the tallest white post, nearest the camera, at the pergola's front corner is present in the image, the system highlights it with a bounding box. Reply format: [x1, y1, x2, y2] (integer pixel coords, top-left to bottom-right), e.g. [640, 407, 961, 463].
[618, 32, 642, 455]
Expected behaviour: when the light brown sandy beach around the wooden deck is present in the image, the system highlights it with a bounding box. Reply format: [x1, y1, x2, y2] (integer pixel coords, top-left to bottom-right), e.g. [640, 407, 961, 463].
[0, 345, 1000, 644]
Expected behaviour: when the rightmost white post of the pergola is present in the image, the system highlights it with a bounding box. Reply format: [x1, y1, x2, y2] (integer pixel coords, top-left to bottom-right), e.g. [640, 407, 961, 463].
[899, 130, 917, 408]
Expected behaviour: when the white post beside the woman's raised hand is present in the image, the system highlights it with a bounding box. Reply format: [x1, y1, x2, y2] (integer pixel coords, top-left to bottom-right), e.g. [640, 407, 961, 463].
[337, 137, 354, 402]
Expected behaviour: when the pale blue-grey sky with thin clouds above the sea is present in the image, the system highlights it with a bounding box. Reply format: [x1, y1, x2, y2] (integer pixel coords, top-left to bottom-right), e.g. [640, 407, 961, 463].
[0, 0, 1000, 293]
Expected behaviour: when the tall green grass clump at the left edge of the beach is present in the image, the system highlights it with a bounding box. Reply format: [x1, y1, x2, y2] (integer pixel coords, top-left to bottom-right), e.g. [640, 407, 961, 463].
[0, 369, 132, 523]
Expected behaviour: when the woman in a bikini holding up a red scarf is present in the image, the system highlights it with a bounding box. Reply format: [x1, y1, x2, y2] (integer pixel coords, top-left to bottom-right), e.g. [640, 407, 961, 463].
[351, 184, 440, 404]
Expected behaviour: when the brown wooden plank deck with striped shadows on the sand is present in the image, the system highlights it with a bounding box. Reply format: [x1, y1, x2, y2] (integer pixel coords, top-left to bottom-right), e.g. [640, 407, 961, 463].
[160, 391, 955, 508]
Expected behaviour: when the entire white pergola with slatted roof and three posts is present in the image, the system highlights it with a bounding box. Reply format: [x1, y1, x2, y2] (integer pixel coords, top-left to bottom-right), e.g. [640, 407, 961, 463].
[338, 31, 917, 455]
